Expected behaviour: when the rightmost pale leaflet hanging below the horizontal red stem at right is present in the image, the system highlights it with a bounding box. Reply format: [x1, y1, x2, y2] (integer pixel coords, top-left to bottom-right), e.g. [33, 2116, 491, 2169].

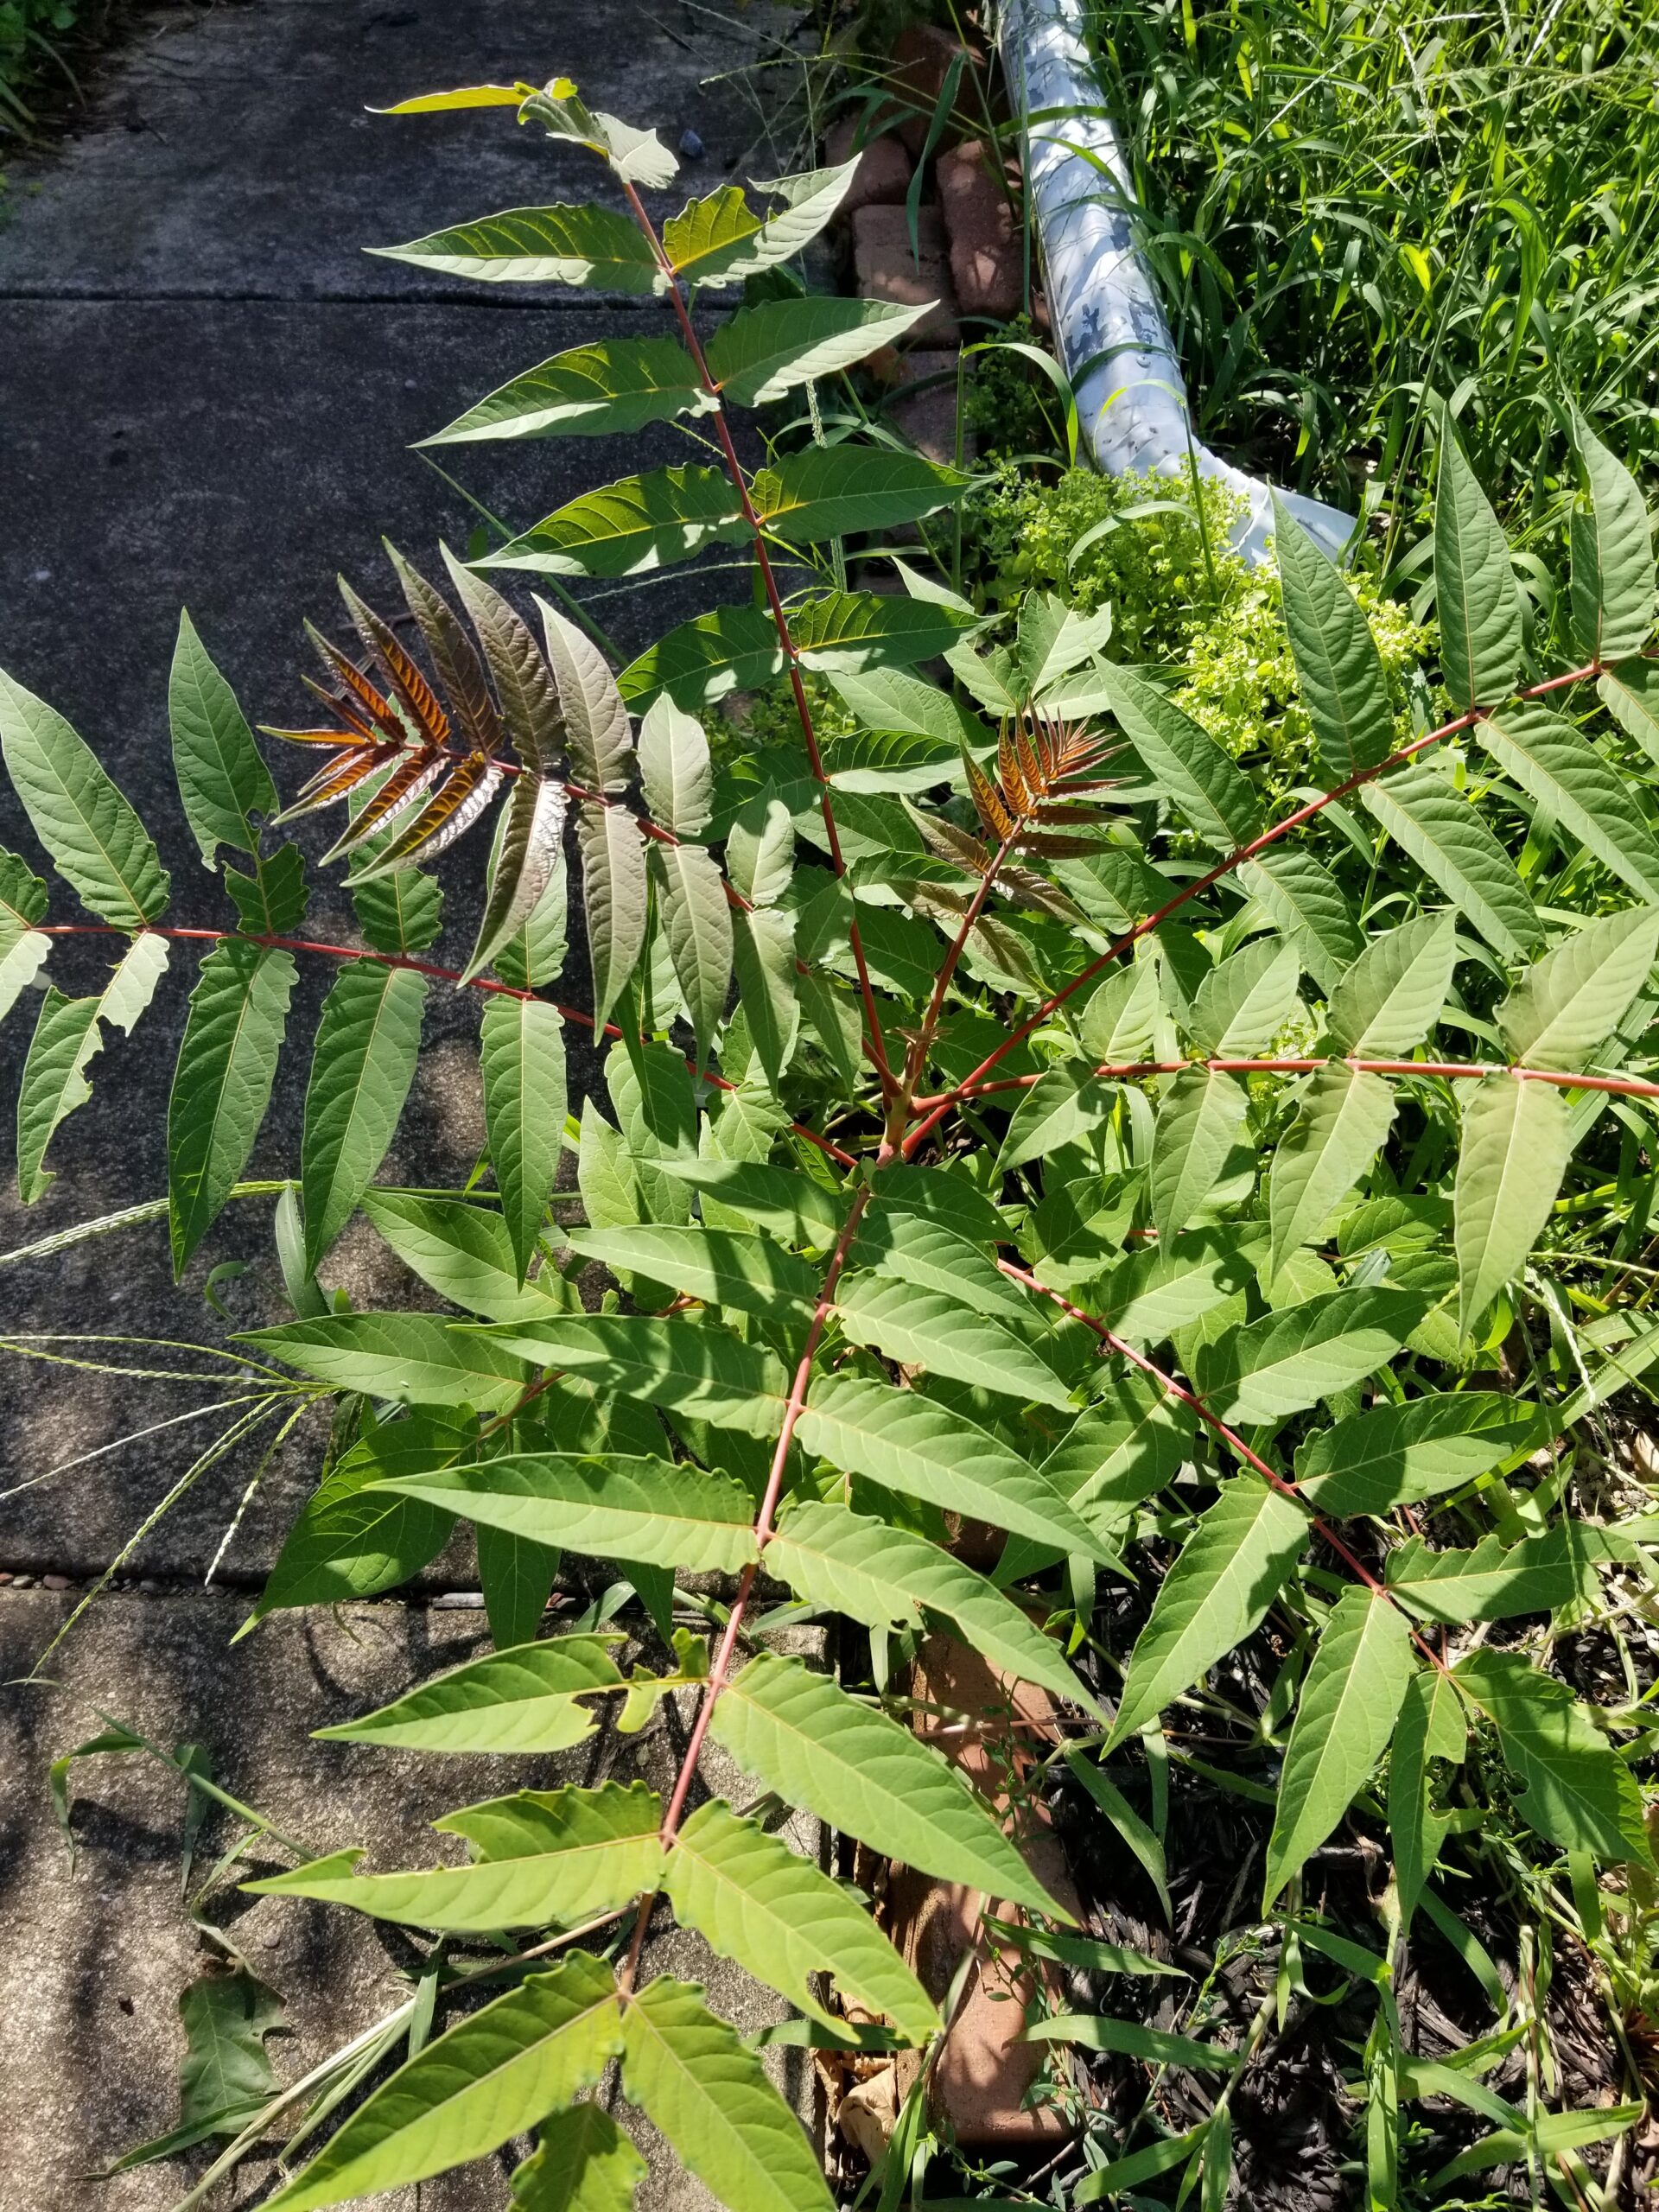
[1453, 1075, 1573, 1336]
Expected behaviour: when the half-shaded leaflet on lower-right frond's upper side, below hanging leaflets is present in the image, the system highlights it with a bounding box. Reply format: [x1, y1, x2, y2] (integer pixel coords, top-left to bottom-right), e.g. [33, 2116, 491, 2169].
[1192, 1289, 1427, 1422]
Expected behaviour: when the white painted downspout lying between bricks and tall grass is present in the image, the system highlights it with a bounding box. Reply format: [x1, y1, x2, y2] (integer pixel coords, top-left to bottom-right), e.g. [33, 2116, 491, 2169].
[1000, 0, 1354, 566]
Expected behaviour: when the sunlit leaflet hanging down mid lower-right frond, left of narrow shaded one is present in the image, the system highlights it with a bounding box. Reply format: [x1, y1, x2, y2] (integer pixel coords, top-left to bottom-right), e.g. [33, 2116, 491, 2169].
[1261, 1588, 1414, 1913]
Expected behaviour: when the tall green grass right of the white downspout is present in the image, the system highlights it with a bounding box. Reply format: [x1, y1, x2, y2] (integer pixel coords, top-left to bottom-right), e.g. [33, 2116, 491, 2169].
[1090, 0, 1659, 575]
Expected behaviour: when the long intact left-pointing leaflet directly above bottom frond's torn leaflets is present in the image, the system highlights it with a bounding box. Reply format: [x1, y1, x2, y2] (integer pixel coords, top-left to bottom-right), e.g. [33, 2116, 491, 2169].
[373, 1451, 757, 1575]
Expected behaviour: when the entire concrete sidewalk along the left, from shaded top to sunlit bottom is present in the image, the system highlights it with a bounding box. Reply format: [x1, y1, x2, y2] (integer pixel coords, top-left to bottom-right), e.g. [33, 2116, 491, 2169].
[0, 0, 827, 2212]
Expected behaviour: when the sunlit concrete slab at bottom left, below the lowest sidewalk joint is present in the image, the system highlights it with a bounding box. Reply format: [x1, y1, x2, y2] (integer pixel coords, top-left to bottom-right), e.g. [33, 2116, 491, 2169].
[0, 1591, 817, 2212]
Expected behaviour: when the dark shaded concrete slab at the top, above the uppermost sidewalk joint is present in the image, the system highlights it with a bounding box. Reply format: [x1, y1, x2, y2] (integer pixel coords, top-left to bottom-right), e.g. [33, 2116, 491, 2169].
[0, 0, 807, 299]
